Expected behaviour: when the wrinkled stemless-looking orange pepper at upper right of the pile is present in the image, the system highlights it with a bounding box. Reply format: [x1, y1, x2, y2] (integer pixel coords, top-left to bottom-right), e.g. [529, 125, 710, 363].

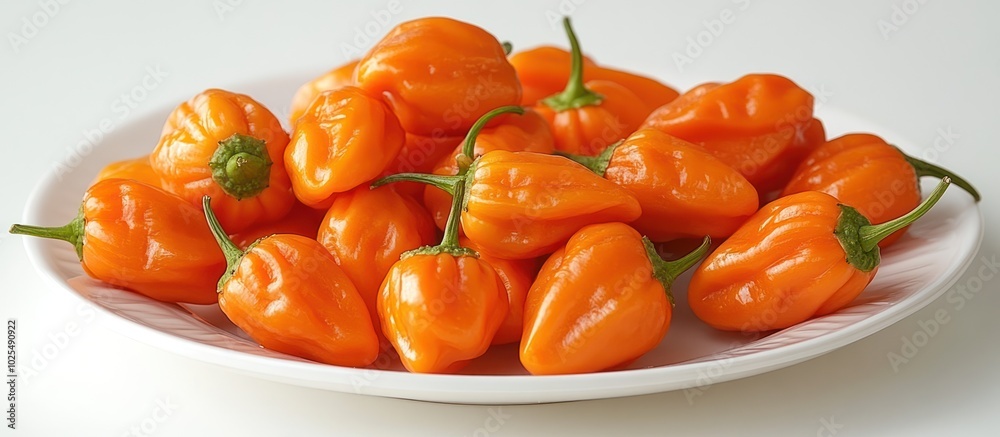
[642, 74, 826, 197]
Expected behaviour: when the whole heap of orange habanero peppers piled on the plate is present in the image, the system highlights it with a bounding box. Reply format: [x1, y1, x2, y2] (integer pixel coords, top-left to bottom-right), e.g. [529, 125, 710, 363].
[10, 17, 979, 375]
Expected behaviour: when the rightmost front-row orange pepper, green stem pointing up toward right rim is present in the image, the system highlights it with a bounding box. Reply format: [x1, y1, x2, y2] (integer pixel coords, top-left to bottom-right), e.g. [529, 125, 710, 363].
[688, 176, 951, 332]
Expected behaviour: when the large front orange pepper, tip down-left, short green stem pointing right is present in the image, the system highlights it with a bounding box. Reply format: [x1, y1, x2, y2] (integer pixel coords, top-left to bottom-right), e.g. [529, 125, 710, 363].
[520, 223, 711, 375]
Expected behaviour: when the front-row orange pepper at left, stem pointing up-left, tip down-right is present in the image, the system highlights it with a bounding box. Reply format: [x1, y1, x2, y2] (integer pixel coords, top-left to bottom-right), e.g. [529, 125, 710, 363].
[203, 196, 378, 367]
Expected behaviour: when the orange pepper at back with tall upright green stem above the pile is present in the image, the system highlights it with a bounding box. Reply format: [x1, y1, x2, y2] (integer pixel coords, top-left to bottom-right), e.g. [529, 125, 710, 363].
[535, 18, 650, 155]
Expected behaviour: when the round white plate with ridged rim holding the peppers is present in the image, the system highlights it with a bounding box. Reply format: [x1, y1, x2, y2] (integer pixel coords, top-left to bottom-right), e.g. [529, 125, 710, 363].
[17, 77, 983, 404]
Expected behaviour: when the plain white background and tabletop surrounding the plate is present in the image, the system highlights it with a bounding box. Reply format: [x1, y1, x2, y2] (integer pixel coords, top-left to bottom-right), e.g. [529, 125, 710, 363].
[0, 0, 1000, 436]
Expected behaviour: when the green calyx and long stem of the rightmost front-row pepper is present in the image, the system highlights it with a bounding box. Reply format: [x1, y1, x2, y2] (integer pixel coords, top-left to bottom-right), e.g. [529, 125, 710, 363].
[833, 176, 951, 272]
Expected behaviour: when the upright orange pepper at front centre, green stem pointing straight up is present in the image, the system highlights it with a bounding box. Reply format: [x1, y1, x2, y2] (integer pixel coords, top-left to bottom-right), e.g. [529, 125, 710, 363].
[378, 177, 508, 373]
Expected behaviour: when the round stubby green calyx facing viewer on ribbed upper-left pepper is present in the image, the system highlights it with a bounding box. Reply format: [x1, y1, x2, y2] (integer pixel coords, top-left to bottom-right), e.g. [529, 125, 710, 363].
[208, 134, 272, 200]
